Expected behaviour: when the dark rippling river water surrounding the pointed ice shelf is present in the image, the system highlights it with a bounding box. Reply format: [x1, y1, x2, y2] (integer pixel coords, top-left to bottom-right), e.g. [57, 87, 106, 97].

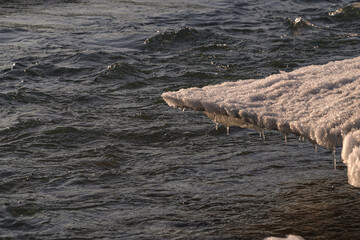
[0, 0, 360, 239]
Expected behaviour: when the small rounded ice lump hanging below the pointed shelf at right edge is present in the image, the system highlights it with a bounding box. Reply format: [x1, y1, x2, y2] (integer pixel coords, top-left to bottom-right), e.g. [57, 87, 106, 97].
[341, 130, 360, 187]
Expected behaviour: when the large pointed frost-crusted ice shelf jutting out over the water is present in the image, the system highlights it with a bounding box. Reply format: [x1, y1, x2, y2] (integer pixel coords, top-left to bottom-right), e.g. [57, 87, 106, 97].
[162, 57, 360, 187]
